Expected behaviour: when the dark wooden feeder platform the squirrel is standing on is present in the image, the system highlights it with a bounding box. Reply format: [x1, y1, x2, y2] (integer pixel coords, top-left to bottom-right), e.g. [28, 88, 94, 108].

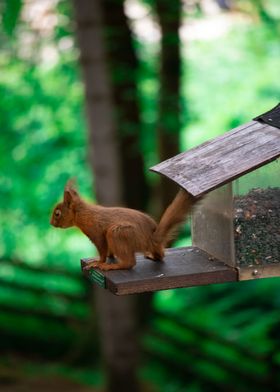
[81, 247, 238, 295]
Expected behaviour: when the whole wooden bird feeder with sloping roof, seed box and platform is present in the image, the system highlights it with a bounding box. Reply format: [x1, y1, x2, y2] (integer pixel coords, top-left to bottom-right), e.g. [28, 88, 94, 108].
[82, 104, 280, 295]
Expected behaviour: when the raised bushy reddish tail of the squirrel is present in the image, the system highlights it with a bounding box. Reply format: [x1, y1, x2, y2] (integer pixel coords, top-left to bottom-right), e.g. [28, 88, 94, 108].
[154, 189, 197, 246]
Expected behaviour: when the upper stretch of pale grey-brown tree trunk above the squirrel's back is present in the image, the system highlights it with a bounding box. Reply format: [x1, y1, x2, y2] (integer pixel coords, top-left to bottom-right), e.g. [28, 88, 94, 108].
[74, 0, 122, 205]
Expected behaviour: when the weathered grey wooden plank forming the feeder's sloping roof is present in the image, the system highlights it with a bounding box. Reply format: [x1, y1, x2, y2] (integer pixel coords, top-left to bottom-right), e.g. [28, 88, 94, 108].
[150, 121, 280, 197]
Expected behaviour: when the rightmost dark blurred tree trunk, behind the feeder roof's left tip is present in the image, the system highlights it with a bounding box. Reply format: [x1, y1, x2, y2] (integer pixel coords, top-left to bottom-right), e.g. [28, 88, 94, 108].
[154, 0, 182, 209]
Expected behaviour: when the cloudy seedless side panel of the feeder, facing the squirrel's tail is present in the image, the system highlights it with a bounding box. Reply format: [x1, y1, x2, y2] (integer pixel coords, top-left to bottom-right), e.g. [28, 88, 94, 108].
[192, 183, 235, 266]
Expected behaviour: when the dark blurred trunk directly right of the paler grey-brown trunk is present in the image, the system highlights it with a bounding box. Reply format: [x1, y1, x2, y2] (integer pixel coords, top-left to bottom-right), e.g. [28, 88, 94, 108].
[102, 0, 148, 210]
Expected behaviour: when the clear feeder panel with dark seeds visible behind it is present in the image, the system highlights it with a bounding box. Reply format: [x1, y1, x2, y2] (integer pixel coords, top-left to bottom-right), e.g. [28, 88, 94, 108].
[233, 158, 280, 271]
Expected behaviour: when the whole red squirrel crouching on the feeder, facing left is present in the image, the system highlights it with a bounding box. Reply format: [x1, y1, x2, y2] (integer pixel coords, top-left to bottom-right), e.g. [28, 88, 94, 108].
[50, 181, 196, 270]
